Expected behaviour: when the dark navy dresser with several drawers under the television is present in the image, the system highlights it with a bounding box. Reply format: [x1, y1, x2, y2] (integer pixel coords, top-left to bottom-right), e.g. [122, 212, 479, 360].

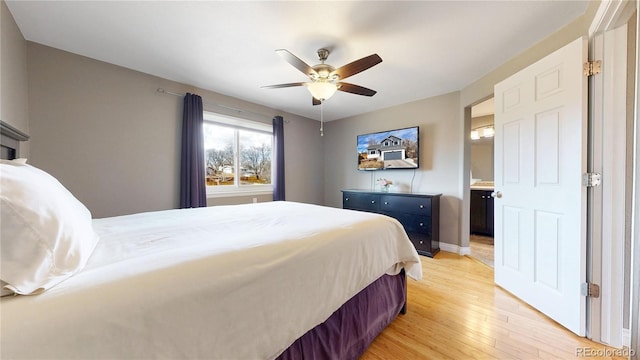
[342, 190, 442, 257]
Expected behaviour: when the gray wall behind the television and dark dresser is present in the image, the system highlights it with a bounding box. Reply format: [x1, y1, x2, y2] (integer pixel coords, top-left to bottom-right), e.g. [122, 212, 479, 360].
[324, 92, 463, 244]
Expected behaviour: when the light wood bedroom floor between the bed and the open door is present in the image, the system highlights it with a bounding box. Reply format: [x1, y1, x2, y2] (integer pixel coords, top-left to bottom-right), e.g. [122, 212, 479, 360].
[361, 251, 627, 360]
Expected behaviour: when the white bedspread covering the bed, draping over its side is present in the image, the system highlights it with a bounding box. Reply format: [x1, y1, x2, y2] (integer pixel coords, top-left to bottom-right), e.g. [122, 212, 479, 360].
[0, 202, 422, 359]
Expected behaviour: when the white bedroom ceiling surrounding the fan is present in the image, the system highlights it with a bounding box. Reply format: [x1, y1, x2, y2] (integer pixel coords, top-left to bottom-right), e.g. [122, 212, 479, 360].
[7, 0, 588, 120]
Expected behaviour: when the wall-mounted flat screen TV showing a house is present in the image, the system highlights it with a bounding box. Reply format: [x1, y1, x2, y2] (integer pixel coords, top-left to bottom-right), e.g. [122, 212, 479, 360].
[358, 126, 420, 170]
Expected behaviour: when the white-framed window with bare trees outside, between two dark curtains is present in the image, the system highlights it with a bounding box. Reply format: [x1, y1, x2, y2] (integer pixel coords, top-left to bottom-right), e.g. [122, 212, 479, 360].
[204, 112, 273, 195]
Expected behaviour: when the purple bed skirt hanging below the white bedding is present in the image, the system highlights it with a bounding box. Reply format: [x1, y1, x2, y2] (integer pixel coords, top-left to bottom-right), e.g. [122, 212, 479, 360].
[277, 271, 406, 360]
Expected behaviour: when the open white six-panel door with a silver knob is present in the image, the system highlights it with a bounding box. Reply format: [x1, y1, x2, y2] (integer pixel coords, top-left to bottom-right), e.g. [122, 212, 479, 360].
[494, 38, 587, 336]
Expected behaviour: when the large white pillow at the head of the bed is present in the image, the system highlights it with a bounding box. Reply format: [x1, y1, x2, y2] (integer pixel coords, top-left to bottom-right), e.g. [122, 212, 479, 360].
[0, 160, 98, 295]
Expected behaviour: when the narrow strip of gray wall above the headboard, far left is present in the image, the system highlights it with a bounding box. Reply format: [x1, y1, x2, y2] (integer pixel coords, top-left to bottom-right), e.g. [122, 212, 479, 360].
[0, 1, 29, 157]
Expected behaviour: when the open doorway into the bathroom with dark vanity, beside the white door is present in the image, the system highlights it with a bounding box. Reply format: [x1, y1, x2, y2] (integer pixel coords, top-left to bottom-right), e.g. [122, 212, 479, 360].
[469, 98, 495, 267]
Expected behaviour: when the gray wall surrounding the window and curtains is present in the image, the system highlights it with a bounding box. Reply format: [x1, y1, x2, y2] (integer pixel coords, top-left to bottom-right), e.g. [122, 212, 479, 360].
[27, 42, 323, 217]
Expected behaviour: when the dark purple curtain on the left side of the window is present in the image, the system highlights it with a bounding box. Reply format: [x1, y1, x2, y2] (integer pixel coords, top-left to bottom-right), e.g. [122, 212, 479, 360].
[180, 93, 207, 209]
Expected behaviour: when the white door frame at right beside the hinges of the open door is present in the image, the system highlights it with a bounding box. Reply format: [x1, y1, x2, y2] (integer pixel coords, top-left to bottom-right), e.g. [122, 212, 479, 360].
[587, 0, 635, 348]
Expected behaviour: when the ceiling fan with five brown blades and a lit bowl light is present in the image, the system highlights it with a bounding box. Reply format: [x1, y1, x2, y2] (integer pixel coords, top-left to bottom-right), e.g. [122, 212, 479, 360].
[263, 49, 382, 105]
